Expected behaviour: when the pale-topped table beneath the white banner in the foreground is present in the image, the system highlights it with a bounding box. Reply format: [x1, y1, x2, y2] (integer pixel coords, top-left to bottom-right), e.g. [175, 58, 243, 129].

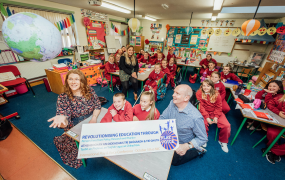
[65, 108, 174, 179]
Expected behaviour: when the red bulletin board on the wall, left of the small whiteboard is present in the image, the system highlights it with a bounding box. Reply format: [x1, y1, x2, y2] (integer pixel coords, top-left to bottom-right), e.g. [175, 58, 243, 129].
[86, 20, 106, 48]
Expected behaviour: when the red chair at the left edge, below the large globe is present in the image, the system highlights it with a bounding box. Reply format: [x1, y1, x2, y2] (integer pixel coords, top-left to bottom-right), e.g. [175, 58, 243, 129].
[0, 65, 35, 95]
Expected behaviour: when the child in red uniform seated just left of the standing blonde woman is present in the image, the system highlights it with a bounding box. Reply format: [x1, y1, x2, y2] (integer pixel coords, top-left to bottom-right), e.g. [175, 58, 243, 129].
[105, 55, 121, 91]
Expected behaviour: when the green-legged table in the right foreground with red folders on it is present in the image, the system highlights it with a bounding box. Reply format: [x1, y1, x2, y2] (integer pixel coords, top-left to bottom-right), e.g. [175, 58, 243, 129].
[227, 88, 285, 157]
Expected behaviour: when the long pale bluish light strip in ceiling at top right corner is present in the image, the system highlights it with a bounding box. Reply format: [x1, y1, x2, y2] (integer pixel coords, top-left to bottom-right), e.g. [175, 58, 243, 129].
[221, 6, 285, 13]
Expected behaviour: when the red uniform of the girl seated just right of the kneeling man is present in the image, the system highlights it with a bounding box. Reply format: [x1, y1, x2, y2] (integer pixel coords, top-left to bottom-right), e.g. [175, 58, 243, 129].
[196, 89, 231, 143]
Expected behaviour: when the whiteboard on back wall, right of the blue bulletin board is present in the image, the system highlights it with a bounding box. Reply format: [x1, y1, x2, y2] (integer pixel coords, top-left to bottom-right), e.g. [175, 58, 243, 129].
[207, 28, 236, 53]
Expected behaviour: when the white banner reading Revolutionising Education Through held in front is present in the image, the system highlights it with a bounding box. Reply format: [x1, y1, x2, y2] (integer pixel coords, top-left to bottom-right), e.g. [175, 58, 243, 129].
[77, 119, 176, 159]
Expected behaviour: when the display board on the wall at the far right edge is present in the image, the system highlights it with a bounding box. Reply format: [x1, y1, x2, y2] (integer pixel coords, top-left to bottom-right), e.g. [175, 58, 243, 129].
[267, 34, 285, 64]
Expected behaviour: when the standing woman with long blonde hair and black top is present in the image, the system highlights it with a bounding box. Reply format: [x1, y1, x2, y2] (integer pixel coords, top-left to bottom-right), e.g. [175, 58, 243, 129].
[119, 46, 139, 100]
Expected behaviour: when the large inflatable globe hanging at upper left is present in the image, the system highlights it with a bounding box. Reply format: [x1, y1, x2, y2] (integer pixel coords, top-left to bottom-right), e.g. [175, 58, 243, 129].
[2, 12, 62, 61]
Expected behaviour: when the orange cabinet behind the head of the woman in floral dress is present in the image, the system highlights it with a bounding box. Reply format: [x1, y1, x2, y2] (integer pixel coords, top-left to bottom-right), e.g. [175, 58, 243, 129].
[60, 64, 101, 85]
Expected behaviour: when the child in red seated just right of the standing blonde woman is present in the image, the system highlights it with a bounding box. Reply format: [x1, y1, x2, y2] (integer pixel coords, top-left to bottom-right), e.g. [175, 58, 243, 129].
[145, 64, 164, 101]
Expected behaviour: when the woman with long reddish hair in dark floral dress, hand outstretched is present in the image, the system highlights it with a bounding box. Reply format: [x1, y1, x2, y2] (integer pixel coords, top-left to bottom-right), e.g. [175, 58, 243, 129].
[48, 70, 101, 168]
